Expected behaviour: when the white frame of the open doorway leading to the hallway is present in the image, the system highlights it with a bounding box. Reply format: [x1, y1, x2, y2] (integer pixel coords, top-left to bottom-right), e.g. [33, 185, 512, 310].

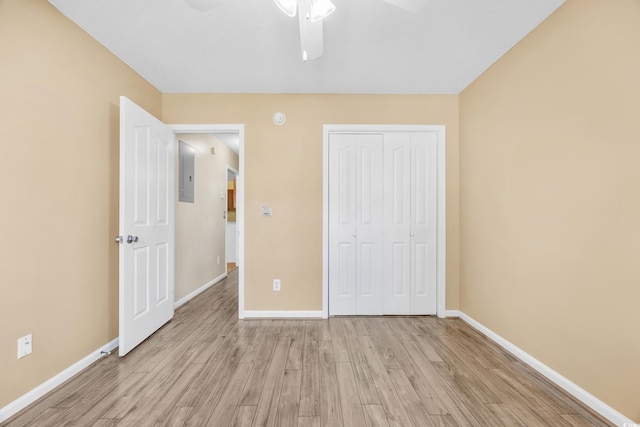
[169, 124, 244, 319]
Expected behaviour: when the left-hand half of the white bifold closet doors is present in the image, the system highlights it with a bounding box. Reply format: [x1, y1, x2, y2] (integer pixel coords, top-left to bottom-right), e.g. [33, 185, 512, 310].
[329, 134, 384, 315]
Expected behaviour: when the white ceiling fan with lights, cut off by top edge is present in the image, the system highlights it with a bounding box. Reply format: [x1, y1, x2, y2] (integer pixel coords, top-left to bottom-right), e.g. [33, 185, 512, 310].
[186, 0, 429, 62]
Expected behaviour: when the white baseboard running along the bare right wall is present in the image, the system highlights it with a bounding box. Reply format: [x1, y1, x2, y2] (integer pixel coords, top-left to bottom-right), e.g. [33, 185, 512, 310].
[458, 310, 637, 426]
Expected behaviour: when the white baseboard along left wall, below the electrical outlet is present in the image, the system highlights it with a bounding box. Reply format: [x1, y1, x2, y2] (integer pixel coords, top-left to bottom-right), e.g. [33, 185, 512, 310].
[0, 338, 118, 423]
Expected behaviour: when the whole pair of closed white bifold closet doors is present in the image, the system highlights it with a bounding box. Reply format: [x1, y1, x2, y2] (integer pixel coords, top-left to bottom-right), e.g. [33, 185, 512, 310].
[329, 132, 437, 315]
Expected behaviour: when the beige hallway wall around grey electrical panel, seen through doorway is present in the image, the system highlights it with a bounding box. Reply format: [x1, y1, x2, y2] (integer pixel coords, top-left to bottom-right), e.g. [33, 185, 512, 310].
[175, 134, 238, 301]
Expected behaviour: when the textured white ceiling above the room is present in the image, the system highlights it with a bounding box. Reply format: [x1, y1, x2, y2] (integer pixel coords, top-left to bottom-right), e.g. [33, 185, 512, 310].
[49, 0, 565, 94]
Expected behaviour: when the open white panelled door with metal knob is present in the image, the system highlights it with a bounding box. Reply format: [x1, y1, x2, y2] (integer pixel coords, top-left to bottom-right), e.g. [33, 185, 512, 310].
[116, 96, 175, 356]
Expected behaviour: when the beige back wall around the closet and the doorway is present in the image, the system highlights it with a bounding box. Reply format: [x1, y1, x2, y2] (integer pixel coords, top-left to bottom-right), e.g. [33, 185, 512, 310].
[162, 94, 459, 310]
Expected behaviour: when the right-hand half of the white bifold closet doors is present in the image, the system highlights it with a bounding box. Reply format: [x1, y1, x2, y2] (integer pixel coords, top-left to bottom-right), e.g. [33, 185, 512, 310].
[384, 132, 437, 314]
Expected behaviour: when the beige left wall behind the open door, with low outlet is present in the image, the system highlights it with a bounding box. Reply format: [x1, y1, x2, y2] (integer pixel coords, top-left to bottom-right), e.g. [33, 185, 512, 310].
[0, 0, 161, 407]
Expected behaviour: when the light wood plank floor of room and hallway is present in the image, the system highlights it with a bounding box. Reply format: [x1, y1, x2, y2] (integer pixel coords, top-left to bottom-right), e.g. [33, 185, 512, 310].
[6, 270, 610, 427]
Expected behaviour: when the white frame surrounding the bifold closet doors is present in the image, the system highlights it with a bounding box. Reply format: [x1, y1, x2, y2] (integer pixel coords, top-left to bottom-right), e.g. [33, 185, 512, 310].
[322, 125, 447, 319]
